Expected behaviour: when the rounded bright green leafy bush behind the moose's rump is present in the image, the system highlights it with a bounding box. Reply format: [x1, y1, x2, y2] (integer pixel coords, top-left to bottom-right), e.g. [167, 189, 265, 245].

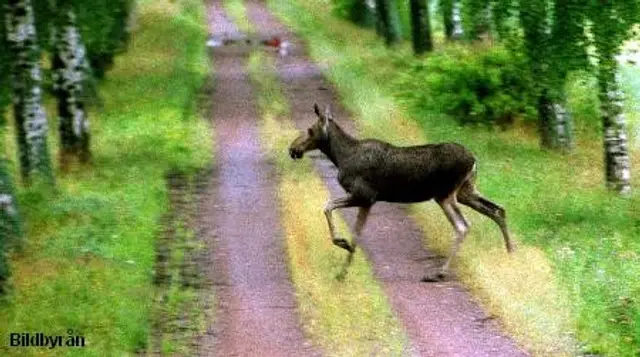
[397, 46, 535, 126]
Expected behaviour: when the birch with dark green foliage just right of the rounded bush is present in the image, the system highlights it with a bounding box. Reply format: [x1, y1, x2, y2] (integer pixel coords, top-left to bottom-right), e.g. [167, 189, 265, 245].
[519, 0, 573, 150]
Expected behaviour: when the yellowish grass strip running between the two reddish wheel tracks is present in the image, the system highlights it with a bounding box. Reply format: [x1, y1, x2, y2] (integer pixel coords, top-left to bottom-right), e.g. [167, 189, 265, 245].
[249, 53, 407, 356]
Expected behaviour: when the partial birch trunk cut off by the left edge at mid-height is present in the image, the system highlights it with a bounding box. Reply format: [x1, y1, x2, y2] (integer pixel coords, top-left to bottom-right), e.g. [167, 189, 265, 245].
[0, 159, 22, 295]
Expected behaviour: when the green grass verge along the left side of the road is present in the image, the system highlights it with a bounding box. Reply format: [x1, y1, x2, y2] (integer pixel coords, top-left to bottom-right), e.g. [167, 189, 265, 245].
[0, 0, 210, 356]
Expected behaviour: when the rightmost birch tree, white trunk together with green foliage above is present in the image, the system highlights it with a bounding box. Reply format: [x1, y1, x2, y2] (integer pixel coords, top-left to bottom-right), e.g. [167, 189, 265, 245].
[588, 0, 640, 194]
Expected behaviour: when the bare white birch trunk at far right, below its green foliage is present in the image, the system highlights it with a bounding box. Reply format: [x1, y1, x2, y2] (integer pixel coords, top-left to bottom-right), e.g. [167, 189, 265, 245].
[598, 68, 631, 195]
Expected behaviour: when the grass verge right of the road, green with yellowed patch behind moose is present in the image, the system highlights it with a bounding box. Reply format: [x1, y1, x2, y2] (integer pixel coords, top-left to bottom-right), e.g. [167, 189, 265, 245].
[269, 0, 640, 356]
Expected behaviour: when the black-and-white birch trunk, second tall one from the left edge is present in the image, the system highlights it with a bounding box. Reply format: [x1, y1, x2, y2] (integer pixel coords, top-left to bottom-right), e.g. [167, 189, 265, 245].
[53, 6, 91, 170]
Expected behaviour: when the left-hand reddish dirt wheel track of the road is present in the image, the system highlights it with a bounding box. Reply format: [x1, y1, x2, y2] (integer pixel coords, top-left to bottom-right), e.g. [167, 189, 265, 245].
[200, 1, 317, 357]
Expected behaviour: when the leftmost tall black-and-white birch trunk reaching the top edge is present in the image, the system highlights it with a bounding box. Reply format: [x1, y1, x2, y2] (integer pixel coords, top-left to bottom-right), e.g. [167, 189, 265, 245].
[5, 0, 54, 184]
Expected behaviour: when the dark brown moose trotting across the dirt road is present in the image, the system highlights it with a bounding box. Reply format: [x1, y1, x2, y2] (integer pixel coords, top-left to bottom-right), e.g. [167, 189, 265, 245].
[289, 104, 513, 282]
